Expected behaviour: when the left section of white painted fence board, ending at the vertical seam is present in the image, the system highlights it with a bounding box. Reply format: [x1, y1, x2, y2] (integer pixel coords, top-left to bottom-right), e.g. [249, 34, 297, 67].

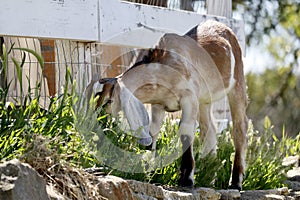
[0, 0, 99, 41]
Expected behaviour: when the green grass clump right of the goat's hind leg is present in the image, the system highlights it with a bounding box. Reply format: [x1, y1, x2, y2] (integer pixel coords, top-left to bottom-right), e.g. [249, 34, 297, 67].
[243, 117, 290, 190]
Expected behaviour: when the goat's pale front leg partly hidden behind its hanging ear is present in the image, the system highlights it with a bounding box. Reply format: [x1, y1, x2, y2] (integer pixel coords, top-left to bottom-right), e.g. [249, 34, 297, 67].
[148, 104, 165, 151]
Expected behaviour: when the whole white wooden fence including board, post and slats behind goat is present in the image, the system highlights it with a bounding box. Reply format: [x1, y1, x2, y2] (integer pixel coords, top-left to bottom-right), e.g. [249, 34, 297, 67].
[0, 0, 245, 130]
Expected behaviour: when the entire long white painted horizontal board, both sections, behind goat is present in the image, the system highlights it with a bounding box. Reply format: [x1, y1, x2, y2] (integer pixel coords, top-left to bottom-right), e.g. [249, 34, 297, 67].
[0, 0, 245, 49]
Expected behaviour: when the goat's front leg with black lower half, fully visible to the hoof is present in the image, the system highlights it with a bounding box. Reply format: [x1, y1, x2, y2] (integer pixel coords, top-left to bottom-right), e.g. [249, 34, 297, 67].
[179, 95, 198, 187]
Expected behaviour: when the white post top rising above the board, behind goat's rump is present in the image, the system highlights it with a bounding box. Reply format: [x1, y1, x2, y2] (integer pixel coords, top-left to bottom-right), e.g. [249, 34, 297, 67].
[206, 0, 232, 18]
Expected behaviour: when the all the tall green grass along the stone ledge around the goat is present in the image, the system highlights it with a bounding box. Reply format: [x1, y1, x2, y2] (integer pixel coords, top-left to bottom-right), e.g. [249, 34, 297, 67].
[0, 46, 300, 189]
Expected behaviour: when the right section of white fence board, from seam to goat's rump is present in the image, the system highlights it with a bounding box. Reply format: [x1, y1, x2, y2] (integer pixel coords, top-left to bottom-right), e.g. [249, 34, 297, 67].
[100, 0, 245, 51]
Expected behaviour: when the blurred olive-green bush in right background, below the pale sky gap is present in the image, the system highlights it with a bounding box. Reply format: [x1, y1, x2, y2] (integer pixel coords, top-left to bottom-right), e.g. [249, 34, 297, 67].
[247, 68, 300, 137]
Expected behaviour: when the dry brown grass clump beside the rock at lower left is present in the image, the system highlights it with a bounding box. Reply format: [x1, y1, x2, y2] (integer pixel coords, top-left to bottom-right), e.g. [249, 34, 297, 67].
[22, 136, 106, 200]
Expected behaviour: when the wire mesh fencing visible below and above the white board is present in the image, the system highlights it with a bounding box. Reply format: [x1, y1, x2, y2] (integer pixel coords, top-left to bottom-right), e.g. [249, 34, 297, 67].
[0, 0, 230, 130]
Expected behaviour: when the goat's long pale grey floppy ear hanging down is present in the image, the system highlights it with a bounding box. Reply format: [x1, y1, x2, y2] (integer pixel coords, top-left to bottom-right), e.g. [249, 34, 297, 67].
[120, 85, 152, 146]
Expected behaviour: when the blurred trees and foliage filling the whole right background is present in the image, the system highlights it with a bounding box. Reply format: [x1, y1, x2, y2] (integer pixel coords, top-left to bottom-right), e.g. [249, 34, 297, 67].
[241, 0, 300, 136]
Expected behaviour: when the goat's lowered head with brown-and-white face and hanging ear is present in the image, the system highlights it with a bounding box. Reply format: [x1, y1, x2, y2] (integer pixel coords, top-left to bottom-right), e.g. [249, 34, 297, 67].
[92, 78, 152, 146]
